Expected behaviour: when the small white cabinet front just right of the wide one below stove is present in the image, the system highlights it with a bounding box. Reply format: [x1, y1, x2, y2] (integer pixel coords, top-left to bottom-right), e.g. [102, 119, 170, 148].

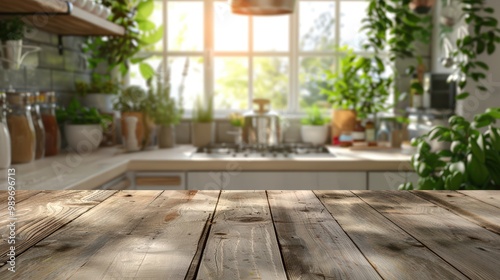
[317, 172, 367, 190]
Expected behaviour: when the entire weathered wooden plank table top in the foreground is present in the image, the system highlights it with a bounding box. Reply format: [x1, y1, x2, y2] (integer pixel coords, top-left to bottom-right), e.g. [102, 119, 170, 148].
[0, 191, 500, 280]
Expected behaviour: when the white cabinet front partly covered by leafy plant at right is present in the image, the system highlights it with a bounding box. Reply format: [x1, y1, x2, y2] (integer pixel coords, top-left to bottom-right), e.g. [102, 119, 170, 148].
[368, 171, 418, 190]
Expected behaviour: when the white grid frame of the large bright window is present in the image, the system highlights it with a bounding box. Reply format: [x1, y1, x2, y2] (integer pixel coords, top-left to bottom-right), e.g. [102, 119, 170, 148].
[141, 0, 373, 118]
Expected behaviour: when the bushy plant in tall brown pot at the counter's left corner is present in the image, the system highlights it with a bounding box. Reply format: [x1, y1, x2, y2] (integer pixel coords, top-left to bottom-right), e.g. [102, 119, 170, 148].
[114, 86, 147, 151]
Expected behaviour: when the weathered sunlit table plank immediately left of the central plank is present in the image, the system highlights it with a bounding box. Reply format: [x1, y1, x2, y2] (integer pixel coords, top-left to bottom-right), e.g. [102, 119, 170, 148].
[70, 191, 219, 279]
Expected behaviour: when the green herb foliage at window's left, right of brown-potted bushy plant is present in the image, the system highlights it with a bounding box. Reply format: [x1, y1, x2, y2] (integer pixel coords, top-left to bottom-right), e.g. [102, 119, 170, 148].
[145, 76, 184, 125]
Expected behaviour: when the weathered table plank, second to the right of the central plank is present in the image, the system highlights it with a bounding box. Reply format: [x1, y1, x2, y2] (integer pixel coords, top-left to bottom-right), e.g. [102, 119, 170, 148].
[315, 191, 467, 280]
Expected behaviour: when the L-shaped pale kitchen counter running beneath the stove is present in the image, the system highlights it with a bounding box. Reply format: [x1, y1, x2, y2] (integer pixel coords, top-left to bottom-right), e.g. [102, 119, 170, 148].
[0, 145, 412, 190]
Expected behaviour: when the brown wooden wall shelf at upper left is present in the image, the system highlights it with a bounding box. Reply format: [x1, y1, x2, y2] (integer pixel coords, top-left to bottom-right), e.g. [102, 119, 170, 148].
[0, 0, 125, 36]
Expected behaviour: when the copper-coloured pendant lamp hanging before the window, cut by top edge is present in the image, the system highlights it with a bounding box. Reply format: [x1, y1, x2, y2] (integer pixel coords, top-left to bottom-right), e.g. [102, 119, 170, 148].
[229, 0, 296, 16]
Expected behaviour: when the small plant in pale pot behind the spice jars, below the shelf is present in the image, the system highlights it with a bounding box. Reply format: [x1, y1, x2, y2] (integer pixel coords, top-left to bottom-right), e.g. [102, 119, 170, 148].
[75, 74, 119, 114]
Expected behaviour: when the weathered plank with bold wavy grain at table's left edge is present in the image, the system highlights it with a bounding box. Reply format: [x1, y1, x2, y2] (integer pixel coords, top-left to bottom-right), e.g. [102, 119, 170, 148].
[0, 191, 114, 264]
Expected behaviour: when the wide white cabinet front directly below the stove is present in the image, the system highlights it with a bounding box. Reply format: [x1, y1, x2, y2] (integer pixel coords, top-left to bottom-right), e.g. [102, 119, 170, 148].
[222, 171, 318, 190]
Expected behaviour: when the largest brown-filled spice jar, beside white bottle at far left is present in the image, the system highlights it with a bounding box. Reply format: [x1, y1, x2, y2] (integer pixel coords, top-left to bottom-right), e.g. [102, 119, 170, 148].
[7, 92, 36, 163]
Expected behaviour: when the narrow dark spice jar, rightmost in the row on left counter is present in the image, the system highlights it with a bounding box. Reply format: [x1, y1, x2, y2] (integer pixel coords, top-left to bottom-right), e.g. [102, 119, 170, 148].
[38, 92, 61, 157]
